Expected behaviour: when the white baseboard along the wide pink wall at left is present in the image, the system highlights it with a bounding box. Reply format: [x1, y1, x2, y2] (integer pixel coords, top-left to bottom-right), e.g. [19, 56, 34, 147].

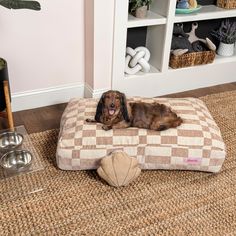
[11, 83, 84, 111]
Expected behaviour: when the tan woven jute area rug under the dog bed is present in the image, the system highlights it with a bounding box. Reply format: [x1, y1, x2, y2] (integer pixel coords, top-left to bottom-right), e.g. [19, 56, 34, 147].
[0, 91, 236, 236]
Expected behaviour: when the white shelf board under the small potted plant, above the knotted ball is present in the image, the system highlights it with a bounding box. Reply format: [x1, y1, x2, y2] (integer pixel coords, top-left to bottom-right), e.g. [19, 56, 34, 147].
[127, 11, 166, 28]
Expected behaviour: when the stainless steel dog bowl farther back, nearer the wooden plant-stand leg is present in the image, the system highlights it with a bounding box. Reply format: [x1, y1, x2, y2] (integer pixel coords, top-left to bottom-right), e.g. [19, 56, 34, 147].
[0, 131, 24, 151]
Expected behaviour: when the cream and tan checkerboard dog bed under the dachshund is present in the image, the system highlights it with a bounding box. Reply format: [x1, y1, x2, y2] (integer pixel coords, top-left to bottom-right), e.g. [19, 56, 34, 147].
[57, 97, 226, 172]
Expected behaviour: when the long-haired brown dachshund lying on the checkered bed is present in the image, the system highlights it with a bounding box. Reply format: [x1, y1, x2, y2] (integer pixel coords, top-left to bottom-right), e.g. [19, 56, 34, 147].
[86, 90, 182, 131]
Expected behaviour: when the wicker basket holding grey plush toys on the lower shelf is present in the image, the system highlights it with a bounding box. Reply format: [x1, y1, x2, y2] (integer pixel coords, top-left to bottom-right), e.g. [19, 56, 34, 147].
[169, 51, 215, 69]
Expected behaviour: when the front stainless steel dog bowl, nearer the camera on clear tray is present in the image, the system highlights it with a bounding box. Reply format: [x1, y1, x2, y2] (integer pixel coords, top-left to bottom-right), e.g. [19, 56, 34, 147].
[0, 150, 32, 171]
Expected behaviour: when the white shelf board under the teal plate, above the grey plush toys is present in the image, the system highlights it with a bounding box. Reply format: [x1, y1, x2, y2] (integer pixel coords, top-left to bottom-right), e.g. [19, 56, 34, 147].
[174, 5, 236, 23]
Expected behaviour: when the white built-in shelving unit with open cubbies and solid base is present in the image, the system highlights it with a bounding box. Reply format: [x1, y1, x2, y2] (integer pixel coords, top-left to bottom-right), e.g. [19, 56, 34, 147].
[112, 0, 236, 96]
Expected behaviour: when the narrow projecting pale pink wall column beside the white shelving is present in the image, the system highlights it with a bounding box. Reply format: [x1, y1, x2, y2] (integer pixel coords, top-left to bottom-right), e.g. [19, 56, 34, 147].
[85, 0, 114, 90]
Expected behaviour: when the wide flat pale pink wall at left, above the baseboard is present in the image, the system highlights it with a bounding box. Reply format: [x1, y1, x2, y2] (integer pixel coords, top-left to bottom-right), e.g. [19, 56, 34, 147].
[0, 0, 84, 93]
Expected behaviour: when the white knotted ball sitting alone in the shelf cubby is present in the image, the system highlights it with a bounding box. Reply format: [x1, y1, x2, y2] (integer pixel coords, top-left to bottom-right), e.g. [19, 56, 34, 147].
[125, 47, 150, 75]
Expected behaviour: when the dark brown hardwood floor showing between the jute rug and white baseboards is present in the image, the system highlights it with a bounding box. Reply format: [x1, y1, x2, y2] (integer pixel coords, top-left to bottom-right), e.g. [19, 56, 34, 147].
[0, 82, 236, 133]
